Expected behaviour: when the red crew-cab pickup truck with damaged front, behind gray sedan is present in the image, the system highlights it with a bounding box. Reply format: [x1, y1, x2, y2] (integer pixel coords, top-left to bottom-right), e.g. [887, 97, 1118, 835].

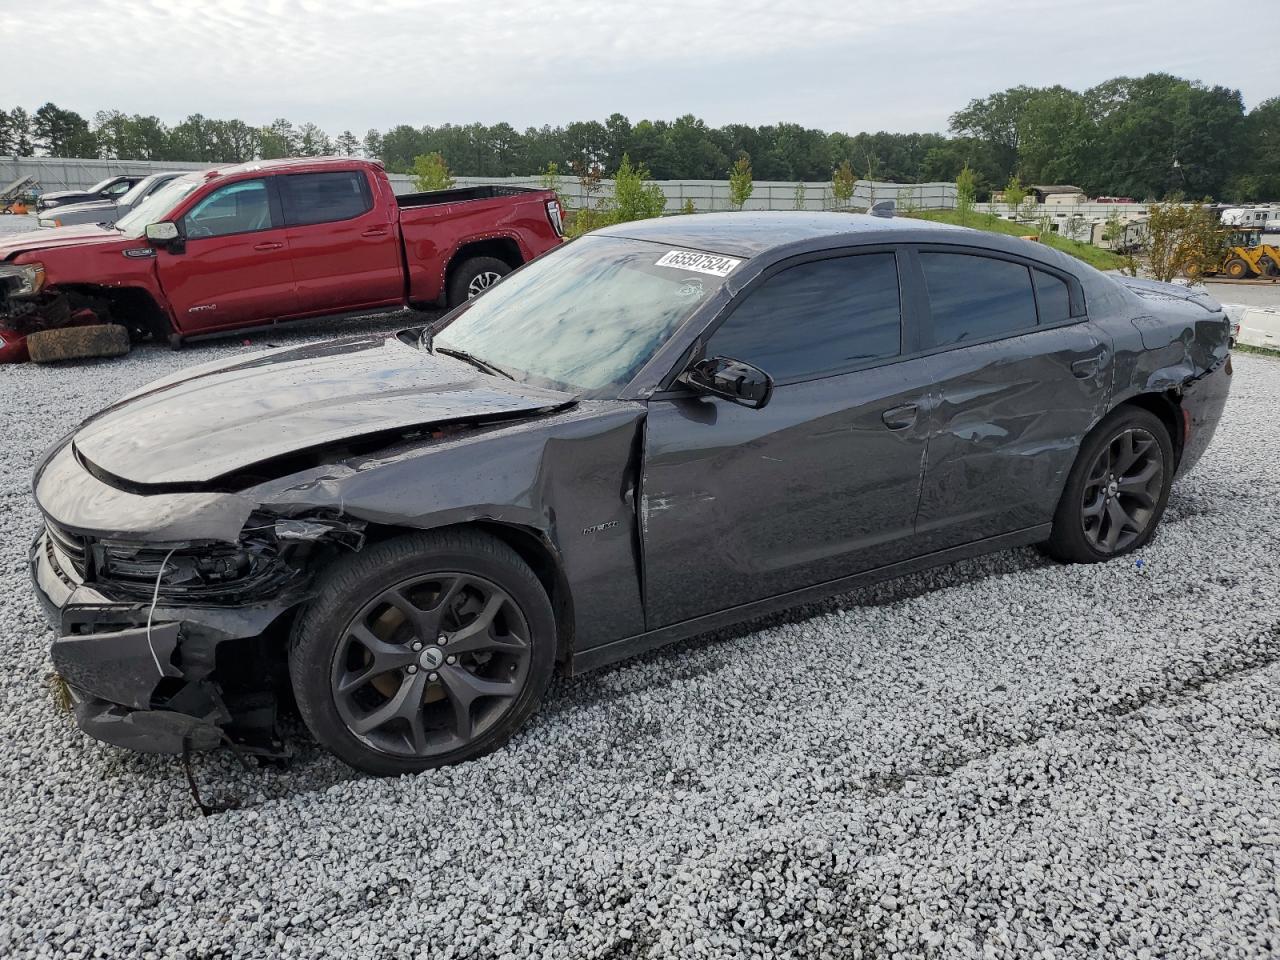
[0, 159, 562, 361]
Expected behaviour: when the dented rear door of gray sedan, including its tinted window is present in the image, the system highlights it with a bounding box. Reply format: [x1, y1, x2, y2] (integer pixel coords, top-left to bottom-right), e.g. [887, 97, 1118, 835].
[916, 248, 1114, 552]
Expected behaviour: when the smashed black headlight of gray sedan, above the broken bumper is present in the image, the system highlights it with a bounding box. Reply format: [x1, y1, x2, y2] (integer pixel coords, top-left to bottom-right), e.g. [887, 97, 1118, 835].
[88, 513, 364, 603]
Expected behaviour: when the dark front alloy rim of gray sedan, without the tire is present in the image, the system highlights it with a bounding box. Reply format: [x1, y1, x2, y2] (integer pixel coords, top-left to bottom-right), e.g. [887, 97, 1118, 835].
[330, 572, 531, 756]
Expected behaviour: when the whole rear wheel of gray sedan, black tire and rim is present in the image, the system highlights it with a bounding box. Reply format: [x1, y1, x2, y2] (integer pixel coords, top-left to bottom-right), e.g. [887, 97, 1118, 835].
[1044, 406, 1176, 563]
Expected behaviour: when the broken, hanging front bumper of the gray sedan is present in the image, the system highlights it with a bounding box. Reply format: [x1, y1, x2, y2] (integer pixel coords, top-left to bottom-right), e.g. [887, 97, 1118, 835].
[29, 530, 298, 754]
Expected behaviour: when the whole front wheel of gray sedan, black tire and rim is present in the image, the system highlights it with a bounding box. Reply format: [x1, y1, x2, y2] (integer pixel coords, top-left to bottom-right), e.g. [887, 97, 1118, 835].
[289, 530, 556, 776]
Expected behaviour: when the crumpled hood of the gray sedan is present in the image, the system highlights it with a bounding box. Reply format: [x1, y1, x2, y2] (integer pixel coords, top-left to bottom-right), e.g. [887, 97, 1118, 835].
[74, 335, 575, 485]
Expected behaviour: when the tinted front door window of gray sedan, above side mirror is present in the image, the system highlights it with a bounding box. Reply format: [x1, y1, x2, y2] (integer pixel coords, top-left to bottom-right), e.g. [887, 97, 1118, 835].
[707, 253, 902, 383]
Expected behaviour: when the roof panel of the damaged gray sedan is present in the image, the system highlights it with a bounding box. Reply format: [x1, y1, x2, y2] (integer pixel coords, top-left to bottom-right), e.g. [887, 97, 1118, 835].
[591, 210, 1092, 276]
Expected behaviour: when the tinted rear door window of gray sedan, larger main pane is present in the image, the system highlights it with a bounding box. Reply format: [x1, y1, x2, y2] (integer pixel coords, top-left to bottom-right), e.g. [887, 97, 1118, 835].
[920, 253, 1036, 347]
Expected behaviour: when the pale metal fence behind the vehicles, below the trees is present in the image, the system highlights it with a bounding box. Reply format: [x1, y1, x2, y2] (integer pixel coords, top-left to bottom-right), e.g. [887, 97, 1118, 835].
[0, 156, 956, 214]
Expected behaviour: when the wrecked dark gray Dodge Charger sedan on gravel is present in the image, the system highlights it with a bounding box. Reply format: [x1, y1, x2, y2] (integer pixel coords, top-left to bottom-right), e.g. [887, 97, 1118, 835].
[31, 212, 1231, 774]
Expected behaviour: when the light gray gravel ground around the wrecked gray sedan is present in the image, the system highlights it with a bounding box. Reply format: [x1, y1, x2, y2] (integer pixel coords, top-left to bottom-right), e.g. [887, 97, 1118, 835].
[0, 328, 1280, 960]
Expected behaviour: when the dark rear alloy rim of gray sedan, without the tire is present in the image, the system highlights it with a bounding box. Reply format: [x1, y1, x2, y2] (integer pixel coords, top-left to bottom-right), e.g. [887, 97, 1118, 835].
[1080, 426, 1165, 554]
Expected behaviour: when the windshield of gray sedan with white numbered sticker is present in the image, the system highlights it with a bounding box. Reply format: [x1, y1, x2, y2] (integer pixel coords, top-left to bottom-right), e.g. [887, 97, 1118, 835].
[434, 237, 740, 397]
